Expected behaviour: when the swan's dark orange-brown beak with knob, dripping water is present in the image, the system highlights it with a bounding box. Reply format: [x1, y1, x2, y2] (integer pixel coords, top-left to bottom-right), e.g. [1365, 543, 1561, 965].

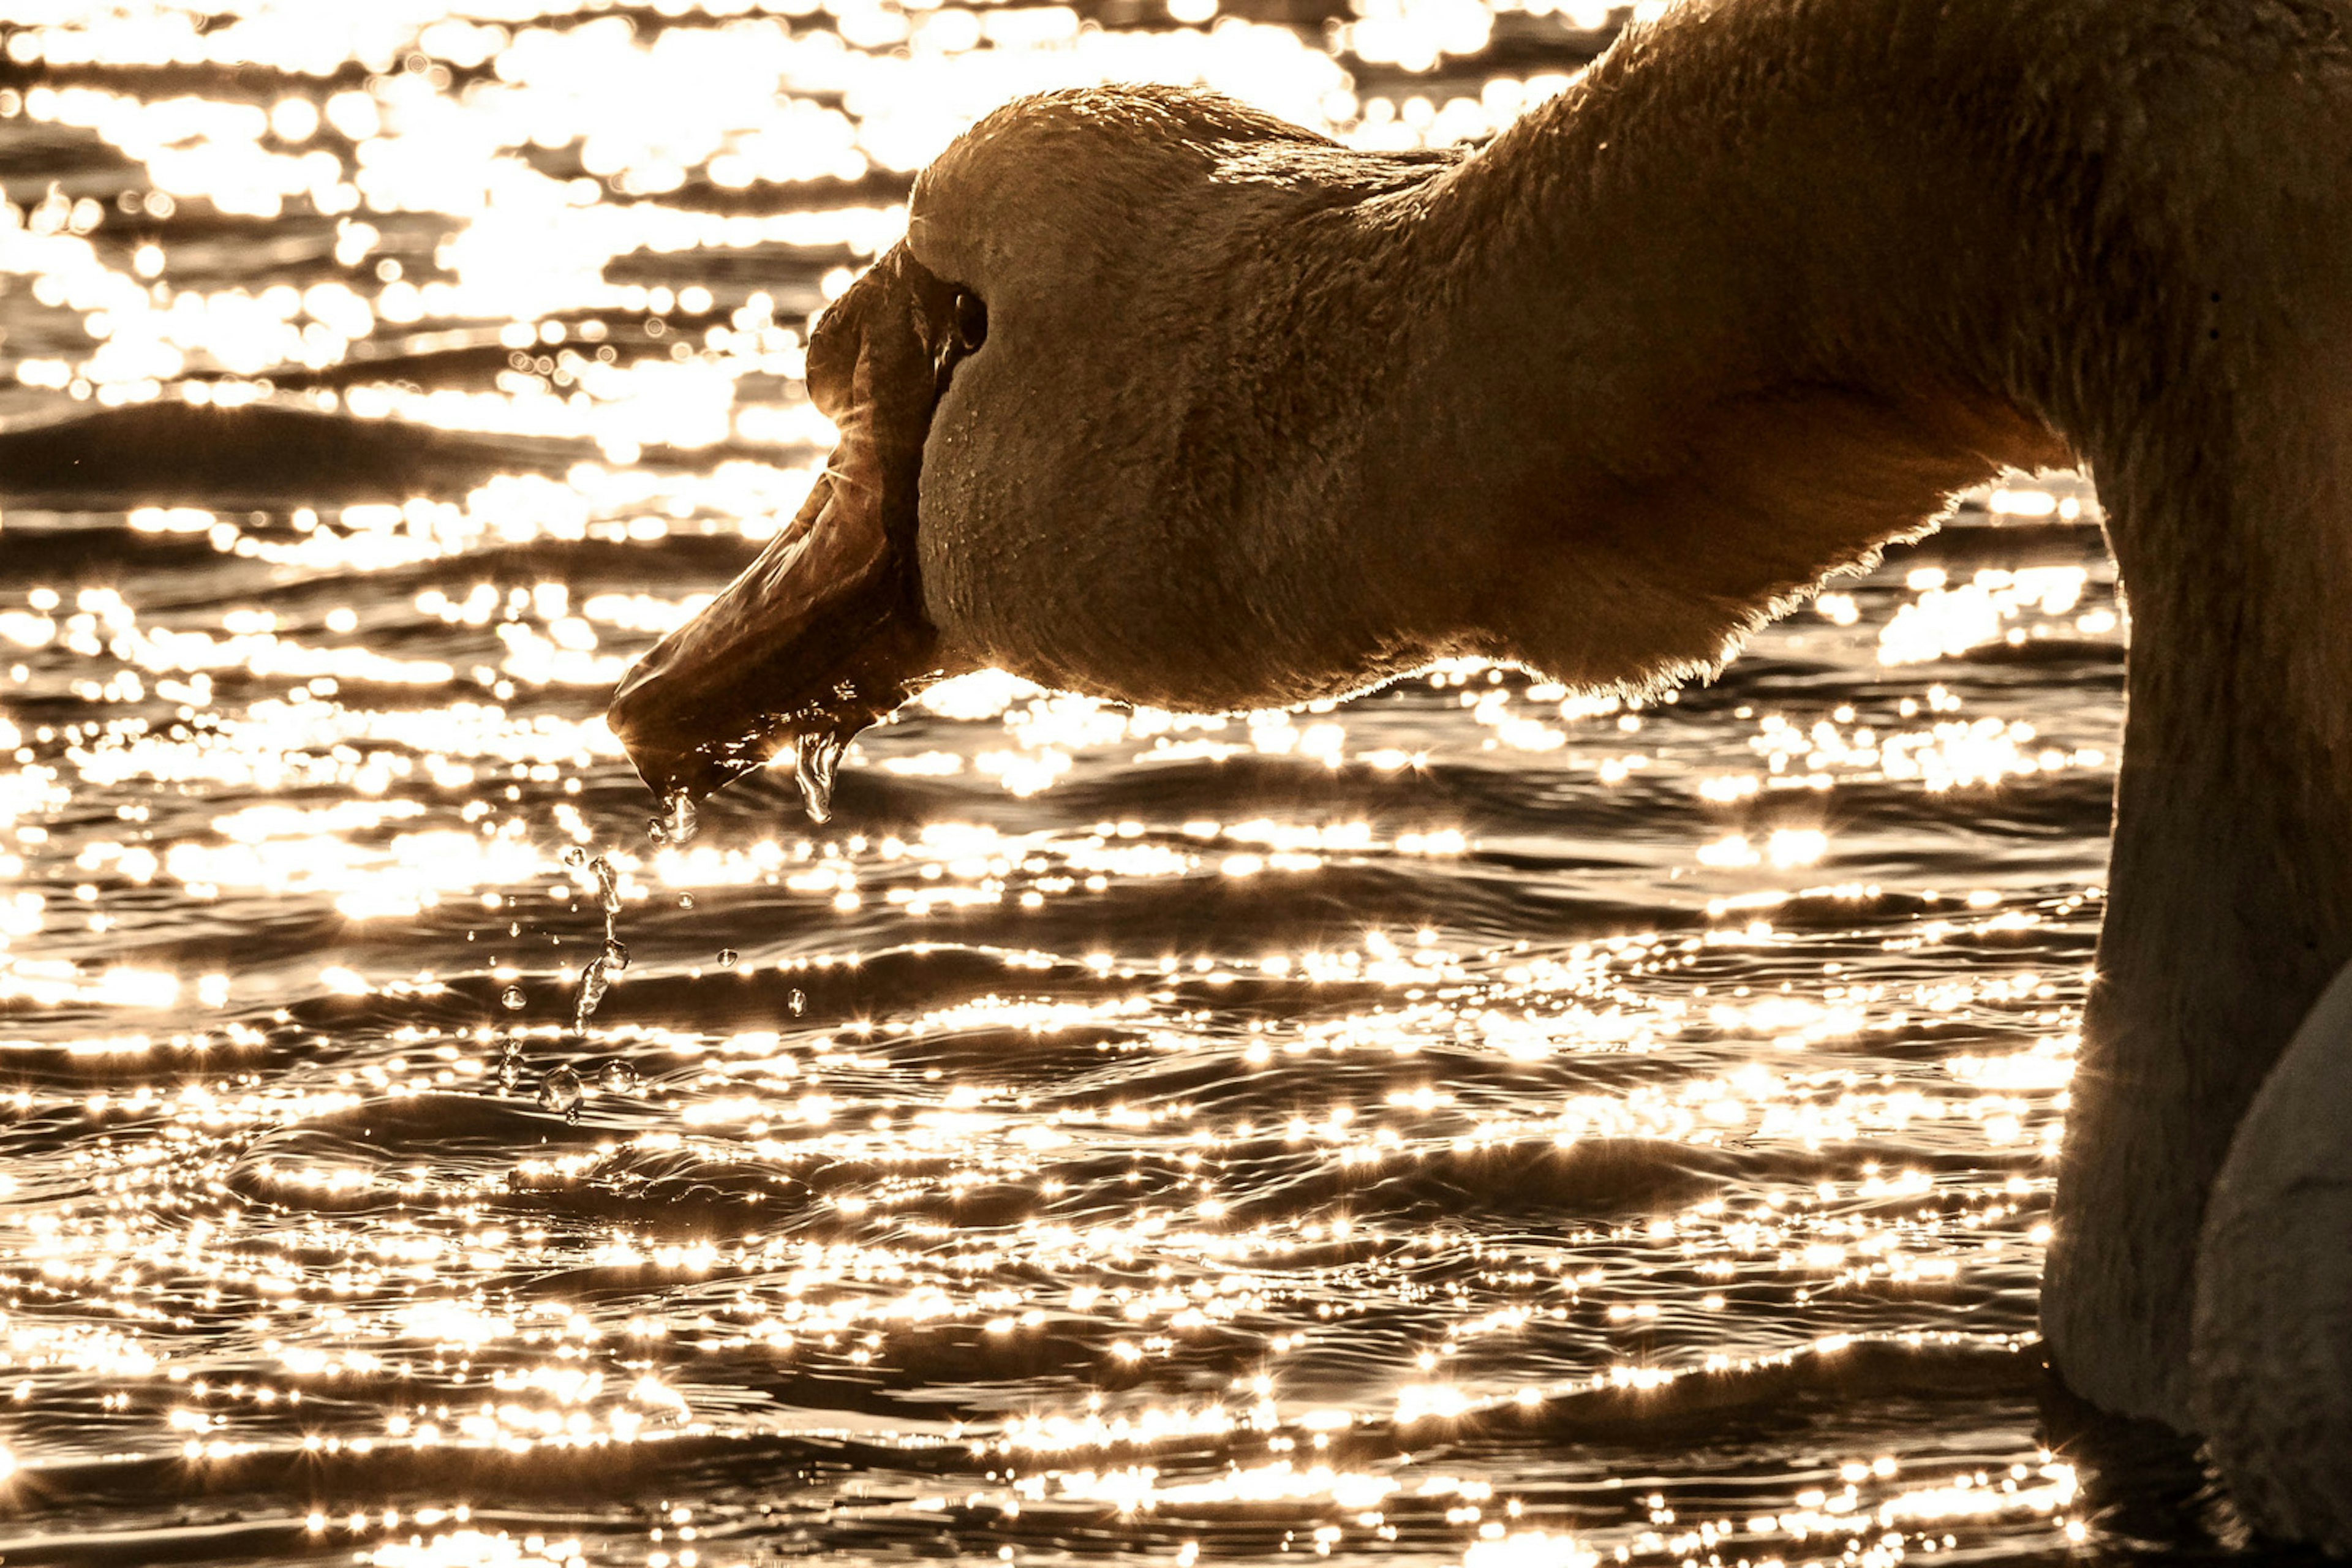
[605, 247, 955, 799]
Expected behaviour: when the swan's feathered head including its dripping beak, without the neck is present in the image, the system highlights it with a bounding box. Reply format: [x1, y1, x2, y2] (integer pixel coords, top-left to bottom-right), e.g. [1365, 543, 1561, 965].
[607, 87, 1451, 794]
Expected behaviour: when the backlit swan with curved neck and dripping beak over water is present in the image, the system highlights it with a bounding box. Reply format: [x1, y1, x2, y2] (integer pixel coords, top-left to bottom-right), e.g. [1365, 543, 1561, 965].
[609, 0, 2352, 1551]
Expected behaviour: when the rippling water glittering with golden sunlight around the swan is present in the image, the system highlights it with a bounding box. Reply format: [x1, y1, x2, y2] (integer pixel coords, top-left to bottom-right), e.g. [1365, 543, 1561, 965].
[0, 0, 2237, 1568]
